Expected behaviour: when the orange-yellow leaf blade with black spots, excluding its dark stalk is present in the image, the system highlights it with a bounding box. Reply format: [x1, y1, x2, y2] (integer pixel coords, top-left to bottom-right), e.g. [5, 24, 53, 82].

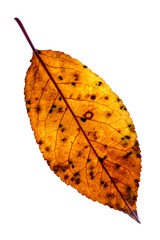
[25, 50, 141, 219]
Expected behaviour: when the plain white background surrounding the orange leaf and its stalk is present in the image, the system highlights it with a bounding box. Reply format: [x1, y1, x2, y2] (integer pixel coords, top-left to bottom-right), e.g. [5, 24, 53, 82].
[0, 0, 160, 240]
